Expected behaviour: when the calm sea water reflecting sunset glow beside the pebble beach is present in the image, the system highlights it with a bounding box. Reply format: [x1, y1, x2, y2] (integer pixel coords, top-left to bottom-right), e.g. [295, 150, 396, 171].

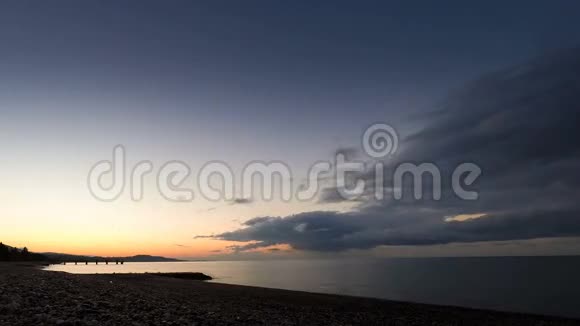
[47, 257, 580, 318]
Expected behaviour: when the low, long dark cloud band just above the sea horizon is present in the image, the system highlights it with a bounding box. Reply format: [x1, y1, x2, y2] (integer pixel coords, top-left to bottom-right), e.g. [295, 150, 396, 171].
[211, 210, 580, 251]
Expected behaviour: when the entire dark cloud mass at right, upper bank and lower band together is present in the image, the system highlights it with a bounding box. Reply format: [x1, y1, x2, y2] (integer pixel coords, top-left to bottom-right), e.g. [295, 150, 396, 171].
[203, 49, 580, 251]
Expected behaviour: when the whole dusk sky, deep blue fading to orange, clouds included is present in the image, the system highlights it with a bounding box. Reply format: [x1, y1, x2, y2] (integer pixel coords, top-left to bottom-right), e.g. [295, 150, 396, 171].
[0, 0, 580, 259]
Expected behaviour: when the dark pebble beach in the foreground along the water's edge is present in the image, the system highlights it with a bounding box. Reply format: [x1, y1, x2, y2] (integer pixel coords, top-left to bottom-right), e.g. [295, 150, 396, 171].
[0, 263, 580, 326]
